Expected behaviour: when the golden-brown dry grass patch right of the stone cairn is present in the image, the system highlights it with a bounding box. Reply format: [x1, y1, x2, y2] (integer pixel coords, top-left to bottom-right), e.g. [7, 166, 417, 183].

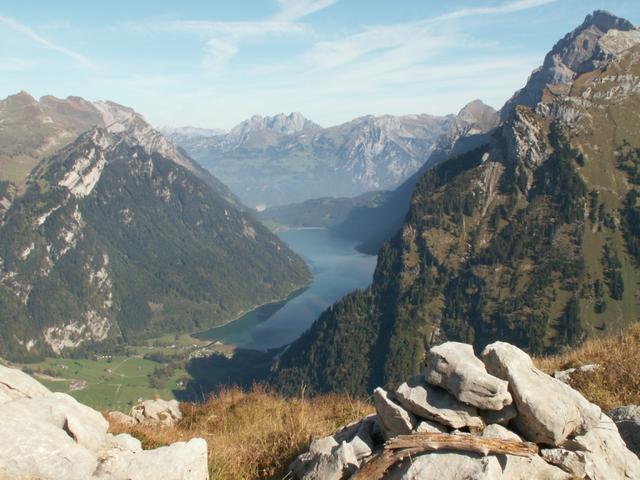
[536, 324, 640, 411]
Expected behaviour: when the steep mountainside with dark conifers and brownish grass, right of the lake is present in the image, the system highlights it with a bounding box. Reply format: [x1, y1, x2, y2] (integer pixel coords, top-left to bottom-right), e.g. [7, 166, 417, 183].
[271, 12, 640, 394]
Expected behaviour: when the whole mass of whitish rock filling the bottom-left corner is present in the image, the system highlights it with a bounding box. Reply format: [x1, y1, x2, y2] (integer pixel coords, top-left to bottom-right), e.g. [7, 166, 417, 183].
[0, 366, 208, 480]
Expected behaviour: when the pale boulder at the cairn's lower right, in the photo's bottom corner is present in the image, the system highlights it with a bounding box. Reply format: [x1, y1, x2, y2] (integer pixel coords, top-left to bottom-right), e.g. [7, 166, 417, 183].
[565, 414, 640, 480]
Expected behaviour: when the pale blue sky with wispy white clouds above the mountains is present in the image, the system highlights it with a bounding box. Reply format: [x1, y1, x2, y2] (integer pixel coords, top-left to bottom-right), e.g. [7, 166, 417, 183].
[0, 0, 640, 128]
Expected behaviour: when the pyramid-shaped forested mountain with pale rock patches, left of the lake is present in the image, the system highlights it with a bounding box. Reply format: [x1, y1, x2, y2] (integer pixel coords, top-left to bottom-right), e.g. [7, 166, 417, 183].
[0, 115, 310, 358]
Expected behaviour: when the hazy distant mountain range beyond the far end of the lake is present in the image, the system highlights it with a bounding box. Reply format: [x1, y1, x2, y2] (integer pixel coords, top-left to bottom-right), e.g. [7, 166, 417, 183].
[172, 113, 453, 210]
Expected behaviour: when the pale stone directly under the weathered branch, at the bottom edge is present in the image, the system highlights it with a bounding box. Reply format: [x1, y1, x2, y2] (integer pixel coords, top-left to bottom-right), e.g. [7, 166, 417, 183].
[384, 452, 504, 480]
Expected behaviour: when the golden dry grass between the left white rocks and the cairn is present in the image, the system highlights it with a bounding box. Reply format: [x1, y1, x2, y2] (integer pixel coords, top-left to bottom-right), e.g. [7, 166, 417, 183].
[111, 387, 373, 479]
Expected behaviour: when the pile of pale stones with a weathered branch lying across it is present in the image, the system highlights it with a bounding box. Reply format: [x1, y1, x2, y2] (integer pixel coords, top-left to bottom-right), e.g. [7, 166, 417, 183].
[290, 342, 640, 480]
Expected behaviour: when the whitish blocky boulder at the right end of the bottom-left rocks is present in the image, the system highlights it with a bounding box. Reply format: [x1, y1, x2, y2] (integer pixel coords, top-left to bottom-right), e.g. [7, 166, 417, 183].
[95, 438, 209, 480]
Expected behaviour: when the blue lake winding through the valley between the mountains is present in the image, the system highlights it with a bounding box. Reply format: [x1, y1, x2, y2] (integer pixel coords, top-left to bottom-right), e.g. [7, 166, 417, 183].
[194, 228, 376, 350]
